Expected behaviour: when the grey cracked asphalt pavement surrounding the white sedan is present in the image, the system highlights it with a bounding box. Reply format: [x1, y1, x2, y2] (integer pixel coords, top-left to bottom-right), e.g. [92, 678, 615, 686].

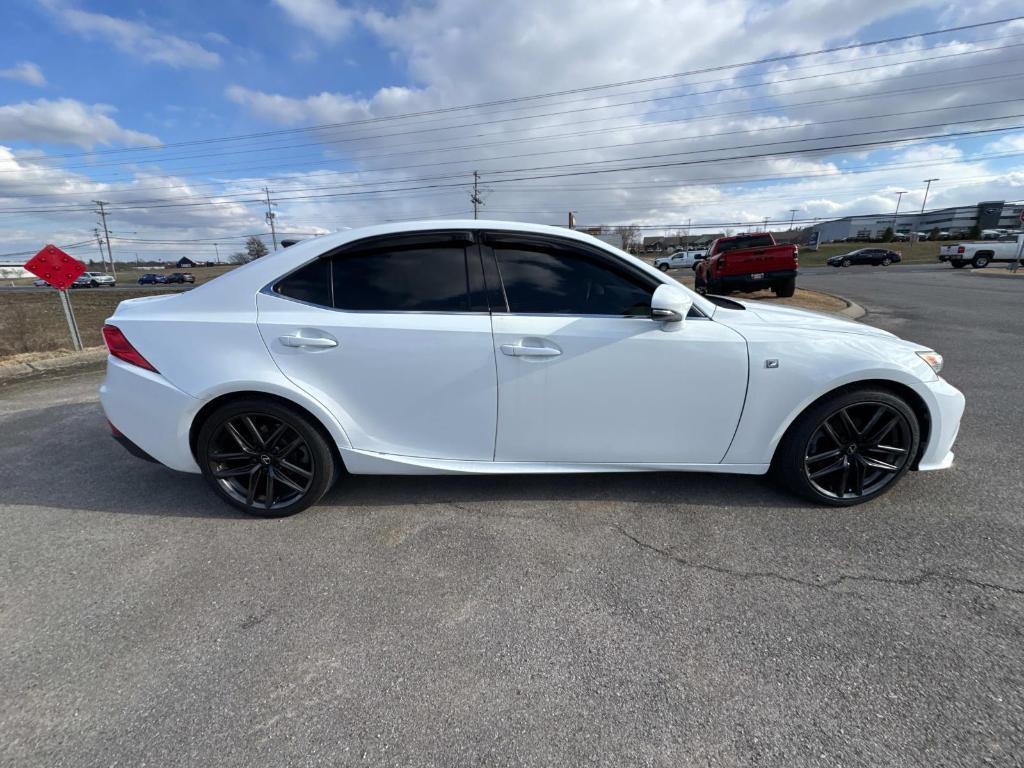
[0, 266, 1024, 767]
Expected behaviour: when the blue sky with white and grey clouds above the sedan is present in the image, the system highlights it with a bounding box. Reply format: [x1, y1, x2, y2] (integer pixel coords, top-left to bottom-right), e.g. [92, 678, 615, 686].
[0, 0, 1024, 259]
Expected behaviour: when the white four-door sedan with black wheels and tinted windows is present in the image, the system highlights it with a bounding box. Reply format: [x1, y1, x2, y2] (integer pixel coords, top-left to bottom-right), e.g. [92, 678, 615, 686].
[100, 225, 964, 516]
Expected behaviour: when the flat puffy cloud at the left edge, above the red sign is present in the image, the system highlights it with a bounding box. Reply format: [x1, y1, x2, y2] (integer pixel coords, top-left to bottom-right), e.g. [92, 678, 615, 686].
[0, 98, 160, 150]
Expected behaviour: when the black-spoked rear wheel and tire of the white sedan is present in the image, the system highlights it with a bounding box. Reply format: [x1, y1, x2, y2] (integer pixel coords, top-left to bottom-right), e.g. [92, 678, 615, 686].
[196, 398, 338, 517]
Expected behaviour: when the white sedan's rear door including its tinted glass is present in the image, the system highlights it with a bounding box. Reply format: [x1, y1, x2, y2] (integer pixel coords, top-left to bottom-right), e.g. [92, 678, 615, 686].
[257, 232, 498, 461]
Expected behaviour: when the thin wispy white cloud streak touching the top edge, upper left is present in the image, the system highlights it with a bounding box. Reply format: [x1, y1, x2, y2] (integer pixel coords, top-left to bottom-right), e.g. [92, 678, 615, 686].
[41, 0, 220, 70]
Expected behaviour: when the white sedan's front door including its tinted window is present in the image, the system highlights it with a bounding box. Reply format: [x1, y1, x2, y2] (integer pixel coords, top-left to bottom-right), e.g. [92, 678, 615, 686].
[483, 233, 748, 464]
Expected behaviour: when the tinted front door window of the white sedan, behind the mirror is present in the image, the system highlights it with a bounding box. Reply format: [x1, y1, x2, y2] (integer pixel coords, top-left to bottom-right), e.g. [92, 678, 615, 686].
[495, 247, 651, 315]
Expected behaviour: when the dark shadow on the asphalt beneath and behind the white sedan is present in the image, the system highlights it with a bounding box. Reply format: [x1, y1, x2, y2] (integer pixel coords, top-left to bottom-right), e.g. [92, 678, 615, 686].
[0, 403, 808, 520]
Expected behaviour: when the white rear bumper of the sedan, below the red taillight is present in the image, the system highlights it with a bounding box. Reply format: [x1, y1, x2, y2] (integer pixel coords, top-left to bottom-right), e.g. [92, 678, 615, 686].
[99, 357, 200, 472]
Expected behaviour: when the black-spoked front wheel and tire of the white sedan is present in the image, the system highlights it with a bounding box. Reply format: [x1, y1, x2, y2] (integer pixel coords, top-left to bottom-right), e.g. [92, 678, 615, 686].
[772, 387, 921, 507]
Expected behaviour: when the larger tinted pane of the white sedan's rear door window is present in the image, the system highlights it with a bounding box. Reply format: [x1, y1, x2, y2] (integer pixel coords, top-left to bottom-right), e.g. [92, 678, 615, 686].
[333, 245, 470, 312]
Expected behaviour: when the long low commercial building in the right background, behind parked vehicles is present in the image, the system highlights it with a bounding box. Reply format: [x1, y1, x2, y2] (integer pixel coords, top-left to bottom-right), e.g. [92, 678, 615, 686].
[811, 200, 1024, 243]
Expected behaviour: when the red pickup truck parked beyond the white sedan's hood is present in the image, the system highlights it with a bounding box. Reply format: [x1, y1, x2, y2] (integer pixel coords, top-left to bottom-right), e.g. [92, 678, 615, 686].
[695, 232, 800, 297]
